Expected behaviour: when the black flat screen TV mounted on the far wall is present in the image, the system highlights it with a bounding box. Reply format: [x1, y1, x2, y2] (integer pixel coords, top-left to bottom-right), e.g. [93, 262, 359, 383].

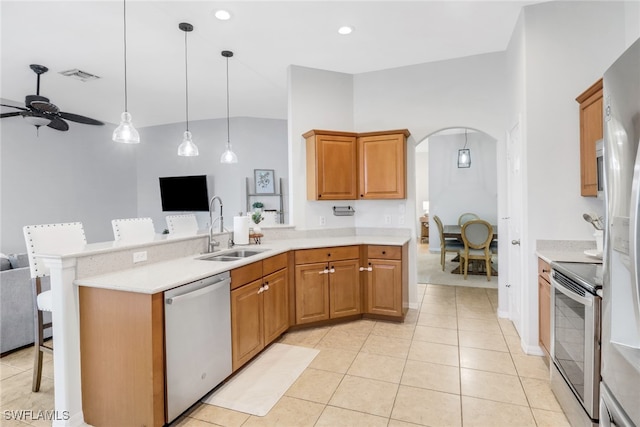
[160, 175, 209, 212]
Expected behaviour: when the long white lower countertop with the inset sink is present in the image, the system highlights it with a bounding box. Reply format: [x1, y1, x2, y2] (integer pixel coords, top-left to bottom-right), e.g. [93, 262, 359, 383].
[74, 235, 409, 294]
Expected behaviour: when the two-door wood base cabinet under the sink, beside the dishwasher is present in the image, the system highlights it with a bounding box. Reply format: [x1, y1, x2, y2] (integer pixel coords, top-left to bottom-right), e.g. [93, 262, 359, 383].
[231, 254, 289, 371]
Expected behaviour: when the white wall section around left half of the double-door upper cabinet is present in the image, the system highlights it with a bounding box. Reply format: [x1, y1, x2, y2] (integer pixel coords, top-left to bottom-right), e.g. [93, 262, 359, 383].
[288, 66, 357, 230]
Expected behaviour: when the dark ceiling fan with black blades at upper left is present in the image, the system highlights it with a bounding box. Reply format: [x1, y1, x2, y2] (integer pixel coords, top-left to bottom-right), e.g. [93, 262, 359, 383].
[0, 64, 104, 131]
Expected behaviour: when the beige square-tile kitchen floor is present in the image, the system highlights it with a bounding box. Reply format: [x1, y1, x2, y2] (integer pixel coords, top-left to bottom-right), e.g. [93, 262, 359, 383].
[0, 285, 569, 427]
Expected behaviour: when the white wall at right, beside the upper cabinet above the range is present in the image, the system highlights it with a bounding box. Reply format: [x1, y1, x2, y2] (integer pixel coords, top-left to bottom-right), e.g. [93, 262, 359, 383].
[508, 1, 627, 347]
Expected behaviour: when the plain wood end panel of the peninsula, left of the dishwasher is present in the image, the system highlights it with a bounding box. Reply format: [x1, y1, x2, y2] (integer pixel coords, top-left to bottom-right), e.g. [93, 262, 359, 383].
[79, 286, 165, 426]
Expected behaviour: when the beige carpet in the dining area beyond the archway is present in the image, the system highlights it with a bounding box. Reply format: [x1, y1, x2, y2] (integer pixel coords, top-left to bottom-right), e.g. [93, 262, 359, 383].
[416, 243, 498, 289]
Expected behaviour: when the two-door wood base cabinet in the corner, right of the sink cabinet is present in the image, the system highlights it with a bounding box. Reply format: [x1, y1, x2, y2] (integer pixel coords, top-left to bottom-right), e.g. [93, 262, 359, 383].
[295, 246, 362, 325]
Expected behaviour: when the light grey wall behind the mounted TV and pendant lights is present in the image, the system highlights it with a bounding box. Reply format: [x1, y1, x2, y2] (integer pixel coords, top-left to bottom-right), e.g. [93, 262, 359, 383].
[136, 117, 288, 233]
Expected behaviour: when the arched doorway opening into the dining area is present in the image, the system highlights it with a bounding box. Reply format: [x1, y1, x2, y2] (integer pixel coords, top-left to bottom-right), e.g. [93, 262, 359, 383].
[415, 127, 499, 288]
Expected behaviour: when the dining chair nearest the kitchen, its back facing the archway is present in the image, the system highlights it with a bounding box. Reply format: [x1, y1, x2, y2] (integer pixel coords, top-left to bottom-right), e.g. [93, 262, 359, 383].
[460, 219, 493, 281]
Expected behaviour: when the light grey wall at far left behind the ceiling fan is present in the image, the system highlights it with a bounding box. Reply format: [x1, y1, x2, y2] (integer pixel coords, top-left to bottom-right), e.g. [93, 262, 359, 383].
[0, 108, 137, 253]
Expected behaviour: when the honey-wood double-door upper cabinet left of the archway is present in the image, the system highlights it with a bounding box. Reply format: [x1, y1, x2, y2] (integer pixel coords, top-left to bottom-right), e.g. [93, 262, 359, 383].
[303, 129, 410, 200]
